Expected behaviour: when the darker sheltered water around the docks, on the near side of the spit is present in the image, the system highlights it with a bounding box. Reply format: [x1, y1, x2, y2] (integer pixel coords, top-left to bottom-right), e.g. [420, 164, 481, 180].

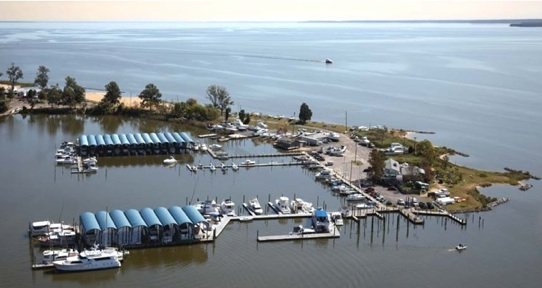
[0, 115, 542, 287]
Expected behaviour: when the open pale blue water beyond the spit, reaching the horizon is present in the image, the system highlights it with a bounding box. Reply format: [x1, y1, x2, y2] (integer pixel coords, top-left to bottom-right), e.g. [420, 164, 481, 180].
[0, 22, 542, 174]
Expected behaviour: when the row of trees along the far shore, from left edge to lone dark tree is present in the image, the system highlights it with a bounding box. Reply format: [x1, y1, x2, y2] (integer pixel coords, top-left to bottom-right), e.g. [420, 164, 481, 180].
[0, 63, 312, 124]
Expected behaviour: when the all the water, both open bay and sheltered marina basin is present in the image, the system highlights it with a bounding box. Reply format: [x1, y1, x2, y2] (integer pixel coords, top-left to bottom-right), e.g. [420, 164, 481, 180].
[0, 23, 542, 287]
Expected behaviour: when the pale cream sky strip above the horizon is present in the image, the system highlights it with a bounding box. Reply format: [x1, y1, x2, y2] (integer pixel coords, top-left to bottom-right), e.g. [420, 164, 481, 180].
[0, 0, 542, 21]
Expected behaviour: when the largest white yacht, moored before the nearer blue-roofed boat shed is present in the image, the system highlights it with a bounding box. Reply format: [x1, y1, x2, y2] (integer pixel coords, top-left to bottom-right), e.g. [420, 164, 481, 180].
[53, 249, 121, 272]
